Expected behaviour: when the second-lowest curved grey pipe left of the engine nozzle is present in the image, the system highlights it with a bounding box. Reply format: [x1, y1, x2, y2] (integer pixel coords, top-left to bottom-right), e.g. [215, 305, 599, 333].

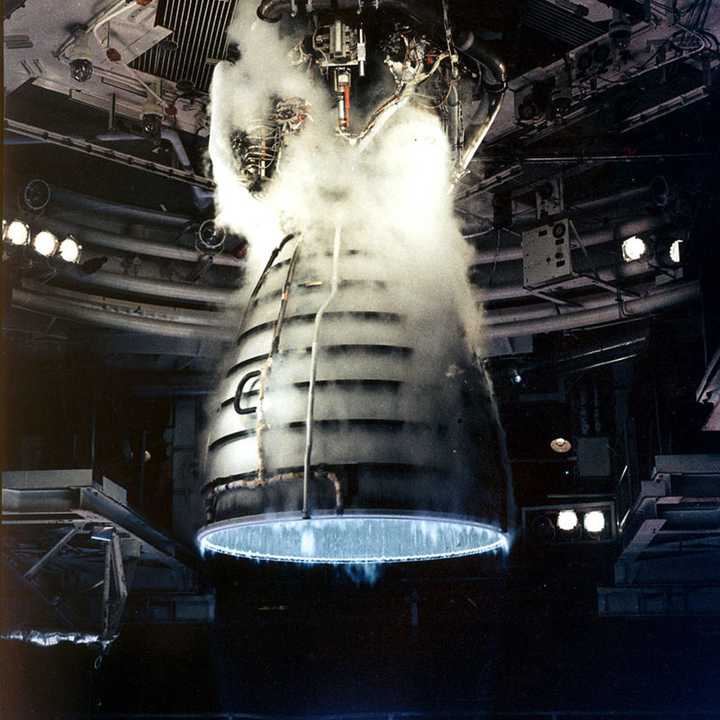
[58, 268, 233, 306]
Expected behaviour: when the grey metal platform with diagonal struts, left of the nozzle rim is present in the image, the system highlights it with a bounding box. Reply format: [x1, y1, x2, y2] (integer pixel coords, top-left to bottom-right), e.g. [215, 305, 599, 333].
[2, 469, 214, 644]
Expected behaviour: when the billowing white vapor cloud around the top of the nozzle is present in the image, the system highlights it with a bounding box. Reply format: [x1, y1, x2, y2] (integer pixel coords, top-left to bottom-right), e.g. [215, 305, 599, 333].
[210, 3, 480, 350]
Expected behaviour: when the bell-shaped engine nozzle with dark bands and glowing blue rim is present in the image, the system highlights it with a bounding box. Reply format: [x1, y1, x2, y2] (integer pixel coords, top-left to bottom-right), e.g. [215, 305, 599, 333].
[197, 231, 507, 563]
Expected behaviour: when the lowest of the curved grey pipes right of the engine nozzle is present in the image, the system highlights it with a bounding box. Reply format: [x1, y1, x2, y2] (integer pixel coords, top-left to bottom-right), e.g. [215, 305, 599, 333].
[485, 282, 700, 338]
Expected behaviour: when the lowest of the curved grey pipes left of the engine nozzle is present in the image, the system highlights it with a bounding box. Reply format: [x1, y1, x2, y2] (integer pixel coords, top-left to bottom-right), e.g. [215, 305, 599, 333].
[12, 289, 230, 342]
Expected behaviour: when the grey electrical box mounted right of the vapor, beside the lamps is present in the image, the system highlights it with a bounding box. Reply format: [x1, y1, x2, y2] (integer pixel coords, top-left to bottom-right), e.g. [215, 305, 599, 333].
[522, 218, 575, 290]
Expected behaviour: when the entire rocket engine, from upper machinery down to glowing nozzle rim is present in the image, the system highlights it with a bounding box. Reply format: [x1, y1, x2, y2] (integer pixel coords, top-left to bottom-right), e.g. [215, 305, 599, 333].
[198, 2, 509, 564]
